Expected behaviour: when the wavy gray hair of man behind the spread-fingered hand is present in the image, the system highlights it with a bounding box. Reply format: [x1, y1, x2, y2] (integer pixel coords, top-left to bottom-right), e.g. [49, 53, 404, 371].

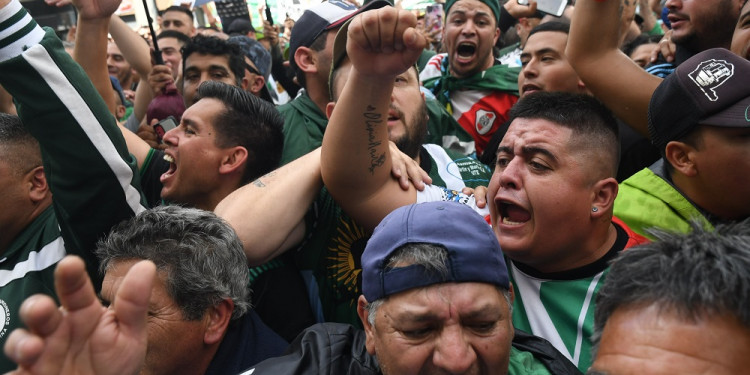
[96, 206, 250, 320]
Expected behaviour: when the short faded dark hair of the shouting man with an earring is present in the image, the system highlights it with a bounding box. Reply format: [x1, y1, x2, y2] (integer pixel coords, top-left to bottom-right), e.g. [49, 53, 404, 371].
[510, 92, 620, 177]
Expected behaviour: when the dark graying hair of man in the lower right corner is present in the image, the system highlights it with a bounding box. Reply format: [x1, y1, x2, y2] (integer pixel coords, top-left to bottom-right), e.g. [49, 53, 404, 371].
[591, 219, 750, 357]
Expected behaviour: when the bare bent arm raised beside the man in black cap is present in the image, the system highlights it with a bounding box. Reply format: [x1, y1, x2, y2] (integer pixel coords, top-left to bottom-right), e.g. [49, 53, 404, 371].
[566, 0, 661, 137]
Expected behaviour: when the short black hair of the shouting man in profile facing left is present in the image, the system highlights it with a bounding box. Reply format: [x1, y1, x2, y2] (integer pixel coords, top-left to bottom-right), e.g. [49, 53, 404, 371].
[196, 81, 284, 185]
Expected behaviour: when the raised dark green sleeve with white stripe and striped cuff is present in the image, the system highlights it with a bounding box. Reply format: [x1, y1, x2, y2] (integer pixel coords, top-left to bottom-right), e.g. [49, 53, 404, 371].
[0, 0, 146, 274]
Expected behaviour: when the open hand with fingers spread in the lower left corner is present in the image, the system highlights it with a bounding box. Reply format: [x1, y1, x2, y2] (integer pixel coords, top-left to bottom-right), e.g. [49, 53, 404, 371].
[5, 256, 156, 375]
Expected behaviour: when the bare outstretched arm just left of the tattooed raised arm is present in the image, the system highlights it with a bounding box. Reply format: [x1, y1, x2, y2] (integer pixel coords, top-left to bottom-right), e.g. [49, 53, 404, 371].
[214, 148, 323, 266]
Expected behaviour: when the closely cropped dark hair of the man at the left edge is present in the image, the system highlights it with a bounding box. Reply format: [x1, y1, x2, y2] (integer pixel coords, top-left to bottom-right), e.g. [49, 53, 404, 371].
[0, 112, 42, 175]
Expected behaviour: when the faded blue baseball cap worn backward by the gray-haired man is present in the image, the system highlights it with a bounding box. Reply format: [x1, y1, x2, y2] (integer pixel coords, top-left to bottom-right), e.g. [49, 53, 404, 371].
[362, 202, 510, 302]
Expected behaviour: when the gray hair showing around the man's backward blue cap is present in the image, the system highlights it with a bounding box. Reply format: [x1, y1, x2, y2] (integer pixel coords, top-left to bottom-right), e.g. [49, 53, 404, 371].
[365, 243, 513, 325]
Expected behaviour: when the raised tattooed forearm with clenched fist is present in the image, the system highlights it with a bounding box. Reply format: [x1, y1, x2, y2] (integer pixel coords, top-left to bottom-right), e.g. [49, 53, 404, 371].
[321, 7, 426, 229]
